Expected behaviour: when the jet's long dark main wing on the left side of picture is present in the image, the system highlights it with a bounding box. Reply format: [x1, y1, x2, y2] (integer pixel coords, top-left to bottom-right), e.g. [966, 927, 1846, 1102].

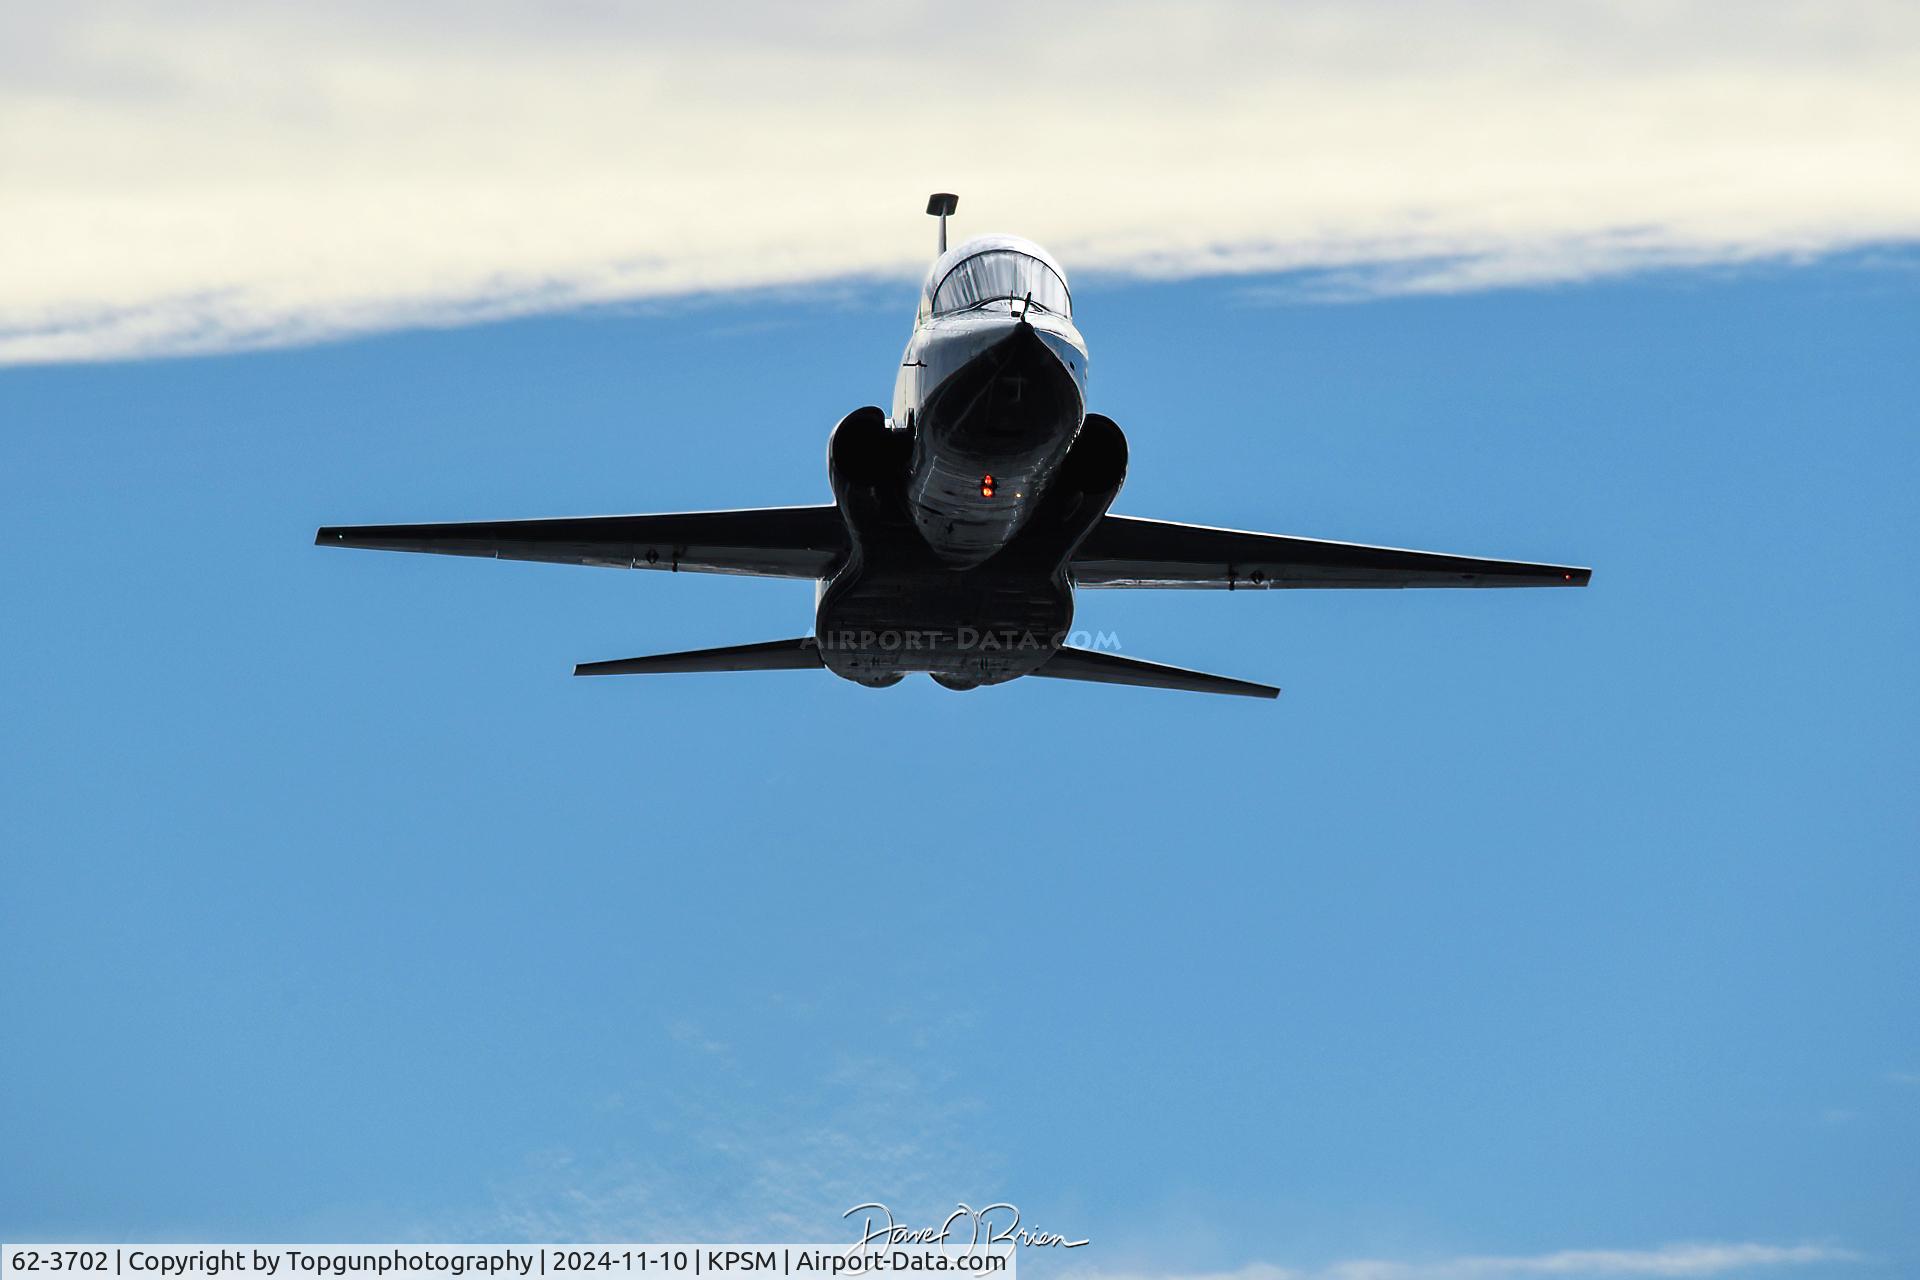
[313, 505, 847, 578]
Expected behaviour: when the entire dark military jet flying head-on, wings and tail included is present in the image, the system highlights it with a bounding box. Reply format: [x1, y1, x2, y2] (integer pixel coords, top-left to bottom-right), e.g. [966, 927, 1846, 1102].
[315, 192, 1590, 699]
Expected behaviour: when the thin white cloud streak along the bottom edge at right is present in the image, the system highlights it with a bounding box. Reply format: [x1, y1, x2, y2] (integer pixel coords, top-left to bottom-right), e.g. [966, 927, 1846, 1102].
[1073, 1244, 1859, 1280]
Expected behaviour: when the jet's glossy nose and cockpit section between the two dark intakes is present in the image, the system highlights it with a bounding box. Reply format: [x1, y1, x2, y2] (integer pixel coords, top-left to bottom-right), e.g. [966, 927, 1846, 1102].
[893, 236, 1087, 566]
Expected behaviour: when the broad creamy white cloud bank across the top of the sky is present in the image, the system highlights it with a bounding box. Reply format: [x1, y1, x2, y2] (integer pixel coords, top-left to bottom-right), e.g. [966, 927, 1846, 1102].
[0, 0, 1920, 361]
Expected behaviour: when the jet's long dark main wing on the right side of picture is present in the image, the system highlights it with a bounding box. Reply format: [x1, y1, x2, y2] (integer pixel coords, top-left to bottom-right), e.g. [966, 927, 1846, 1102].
[1071, 516, 1592, 591]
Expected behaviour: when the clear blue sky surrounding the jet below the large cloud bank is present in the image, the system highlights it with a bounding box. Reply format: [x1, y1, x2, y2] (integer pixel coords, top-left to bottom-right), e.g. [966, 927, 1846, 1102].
[0, 253, 1920, 1278]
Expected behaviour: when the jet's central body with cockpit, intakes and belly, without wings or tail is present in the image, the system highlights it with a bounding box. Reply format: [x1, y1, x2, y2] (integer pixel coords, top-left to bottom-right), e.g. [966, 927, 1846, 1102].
[814, 236, 1125, 689]
